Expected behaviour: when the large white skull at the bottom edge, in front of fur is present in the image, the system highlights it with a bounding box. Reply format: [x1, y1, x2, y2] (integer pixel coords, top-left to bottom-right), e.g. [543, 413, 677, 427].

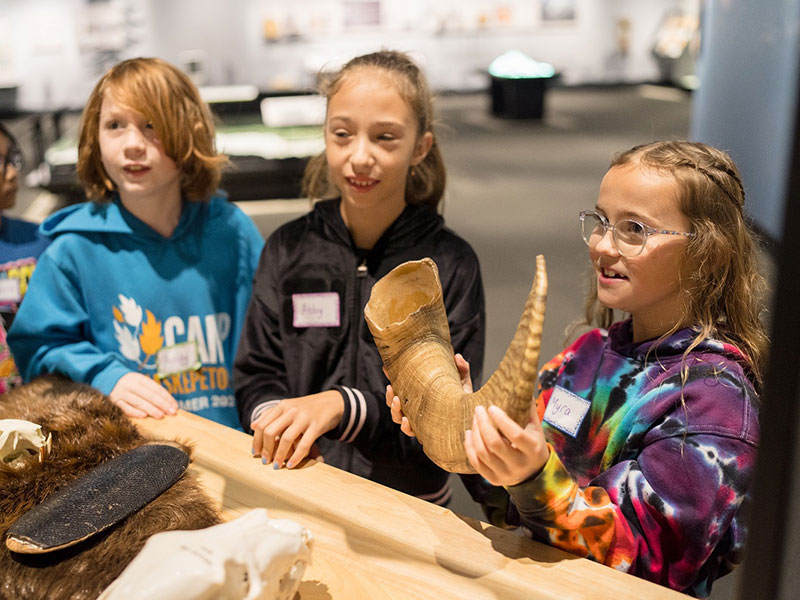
[98, 508, 313, 600]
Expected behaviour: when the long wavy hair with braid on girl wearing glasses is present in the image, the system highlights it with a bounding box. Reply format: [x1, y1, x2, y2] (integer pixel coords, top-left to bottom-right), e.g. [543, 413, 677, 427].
[584, 141, 769, 388]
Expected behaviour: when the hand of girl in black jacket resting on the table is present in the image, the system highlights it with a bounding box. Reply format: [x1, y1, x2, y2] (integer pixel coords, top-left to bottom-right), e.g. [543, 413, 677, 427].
[250, 390, 344, 469]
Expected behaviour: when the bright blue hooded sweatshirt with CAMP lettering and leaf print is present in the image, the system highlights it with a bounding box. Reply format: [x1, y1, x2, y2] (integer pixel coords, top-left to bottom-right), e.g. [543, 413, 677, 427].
[8, 196, 264, 429]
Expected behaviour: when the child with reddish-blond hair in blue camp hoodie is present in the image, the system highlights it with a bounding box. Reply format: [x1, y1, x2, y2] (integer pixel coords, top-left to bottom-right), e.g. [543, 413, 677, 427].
[9, 58, 263, 428]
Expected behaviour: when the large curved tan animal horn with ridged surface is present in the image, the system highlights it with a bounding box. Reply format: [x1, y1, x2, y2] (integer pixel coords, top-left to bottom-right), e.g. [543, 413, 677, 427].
[364, 255, 547, 473]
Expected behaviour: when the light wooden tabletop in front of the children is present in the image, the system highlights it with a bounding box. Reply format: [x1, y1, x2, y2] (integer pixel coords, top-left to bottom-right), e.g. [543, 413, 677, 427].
[134, 411, 685, 600]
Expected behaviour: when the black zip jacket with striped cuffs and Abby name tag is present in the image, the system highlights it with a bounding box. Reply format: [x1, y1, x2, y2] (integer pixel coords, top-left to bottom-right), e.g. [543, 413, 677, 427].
[234, 199, 507, 521]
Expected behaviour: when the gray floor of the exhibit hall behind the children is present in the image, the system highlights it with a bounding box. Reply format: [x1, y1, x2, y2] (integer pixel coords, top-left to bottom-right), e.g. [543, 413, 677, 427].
[7, 86, 744, 600]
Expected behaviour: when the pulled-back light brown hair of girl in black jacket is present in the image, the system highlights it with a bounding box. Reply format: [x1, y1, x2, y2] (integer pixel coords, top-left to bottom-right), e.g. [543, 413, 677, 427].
[303, 50, 446, 208]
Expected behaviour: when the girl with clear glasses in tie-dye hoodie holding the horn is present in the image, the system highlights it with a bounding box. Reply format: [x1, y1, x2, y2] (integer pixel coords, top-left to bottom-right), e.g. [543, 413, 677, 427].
[387, 142, 767, 597]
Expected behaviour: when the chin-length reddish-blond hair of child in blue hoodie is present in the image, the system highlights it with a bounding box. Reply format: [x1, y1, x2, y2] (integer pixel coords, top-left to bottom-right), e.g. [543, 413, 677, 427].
[77, 58, 227, 202]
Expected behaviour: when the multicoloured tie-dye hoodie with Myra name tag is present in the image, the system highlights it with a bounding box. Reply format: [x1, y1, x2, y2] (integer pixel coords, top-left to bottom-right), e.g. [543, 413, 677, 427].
[509, 321, 758, 597]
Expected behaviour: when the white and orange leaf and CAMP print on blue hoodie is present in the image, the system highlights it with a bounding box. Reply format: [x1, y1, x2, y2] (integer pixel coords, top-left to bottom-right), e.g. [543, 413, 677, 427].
[112, 294, 233, 410]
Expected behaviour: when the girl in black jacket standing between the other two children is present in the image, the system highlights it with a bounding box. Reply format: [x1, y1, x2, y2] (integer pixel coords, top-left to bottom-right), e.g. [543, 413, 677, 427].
[234, 51, 507, 524]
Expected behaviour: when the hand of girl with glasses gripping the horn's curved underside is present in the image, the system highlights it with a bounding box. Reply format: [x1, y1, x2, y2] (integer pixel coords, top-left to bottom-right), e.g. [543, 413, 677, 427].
[464, 404, 550, 486]
